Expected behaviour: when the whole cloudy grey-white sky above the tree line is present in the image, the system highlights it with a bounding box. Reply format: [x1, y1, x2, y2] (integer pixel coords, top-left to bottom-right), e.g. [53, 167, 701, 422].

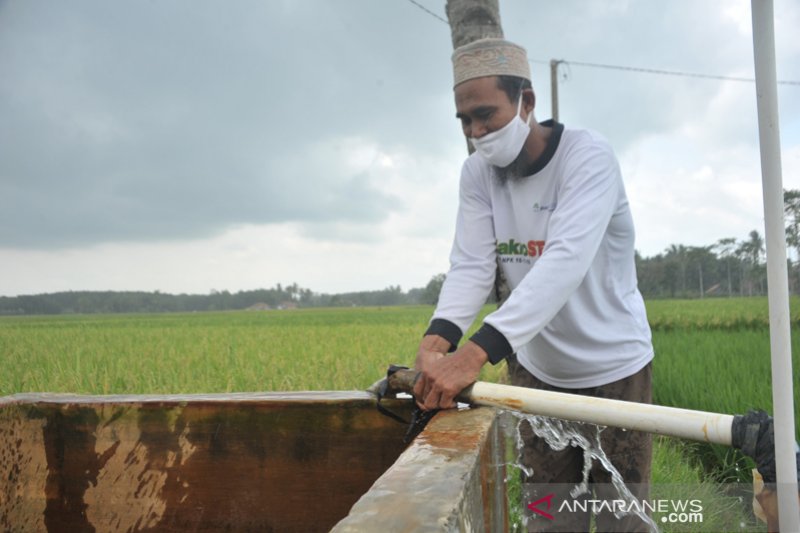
[0, 0, 800, 295]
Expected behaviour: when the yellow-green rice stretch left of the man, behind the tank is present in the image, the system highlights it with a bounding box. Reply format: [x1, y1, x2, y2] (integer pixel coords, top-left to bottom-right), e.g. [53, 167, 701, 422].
[0, 307, 430, 394]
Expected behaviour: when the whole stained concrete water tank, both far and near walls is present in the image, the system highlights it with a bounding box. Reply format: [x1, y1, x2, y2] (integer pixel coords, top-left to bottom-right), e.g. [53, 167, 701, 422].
[0, 392, 507, 533]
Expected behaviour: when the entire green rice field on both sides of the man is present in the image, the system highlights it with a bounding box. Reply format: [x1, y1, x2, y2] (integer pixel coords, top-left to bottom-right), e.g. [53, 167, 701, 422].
[0, 298, 800, 528]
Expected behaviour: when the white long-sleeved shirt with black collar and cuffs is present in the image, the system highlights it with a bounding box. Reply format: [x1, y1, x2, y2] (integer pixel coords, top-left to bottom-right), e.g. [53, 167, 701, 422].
[432, 124, 653, 388]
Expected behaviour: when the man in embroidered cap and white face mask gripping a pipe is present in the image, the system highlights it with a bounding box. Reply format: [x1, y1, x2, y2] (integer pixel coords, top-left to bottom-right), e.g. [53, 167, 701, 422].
[414, 39, 653, 531]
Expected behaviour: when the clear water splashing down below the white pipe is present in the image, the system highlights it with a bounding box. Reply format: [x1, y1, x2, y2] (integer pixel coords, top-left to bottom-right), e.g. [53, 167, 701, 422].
[506, 411, 660, 533]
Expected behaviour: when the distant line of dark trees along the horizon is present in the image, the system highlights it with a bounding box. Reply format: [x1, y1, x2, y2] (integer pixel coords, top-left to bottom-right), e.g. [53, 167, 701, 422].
[6, 190, 800, 315]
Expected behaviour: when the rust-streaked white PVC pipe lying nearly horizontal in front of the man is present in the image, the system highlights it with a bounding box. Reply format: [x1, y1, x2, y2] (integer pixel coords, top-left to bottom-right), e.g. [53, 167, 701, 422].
[468, 381, 733, 446]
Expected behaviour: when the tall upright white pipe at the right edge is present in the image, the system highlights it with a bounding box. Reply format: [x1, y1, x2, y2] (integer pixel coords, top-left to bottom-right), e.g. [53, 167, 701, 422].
[751, 0, 800, 532]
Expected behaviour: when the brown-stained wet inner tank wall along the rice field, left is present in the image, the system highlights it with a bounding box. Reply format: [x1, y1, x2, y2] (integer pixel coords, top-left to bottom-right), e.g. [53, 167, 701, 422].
[0, 392, 418, 533]
